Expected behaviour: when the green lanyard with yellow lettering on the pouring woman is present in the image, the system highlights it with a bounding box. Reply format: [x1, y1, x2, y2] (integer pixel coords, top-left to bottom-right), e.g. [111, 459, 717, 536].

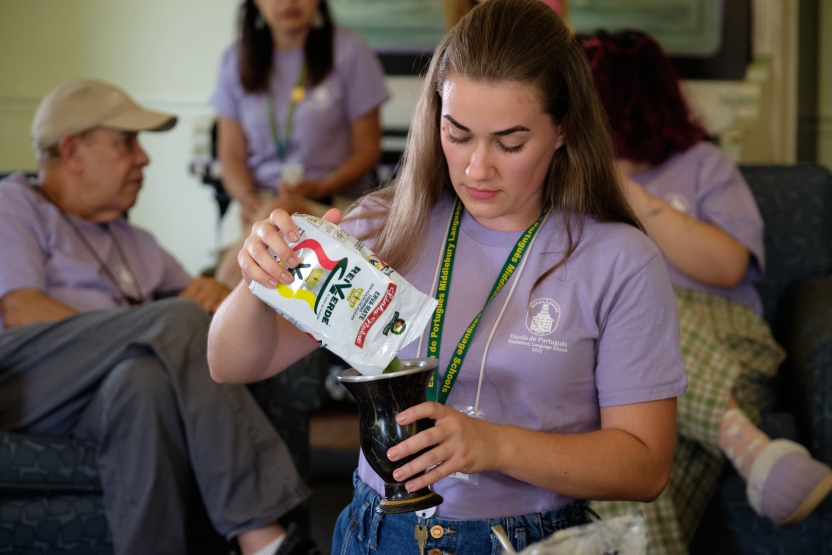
[427, 200, 546, 405]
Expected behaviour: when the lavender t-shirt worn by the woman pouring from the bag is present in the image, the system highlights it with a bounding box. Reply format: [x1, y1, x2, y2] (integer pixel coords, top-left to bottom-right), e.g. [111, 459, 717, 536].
[344, 199, 687, 518]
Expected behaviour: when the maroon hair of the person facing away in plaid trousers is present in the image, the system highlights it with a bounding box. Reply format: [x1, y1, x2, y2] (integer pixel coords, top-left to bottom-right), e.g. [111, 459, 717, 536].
[578, 31, 707, 165]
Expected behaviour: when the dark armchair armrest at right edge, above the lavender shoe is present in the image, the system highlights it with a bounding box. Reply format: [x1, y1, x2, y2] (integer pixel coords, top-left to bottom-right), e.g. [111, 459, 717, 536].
[775, 275, 832, 464]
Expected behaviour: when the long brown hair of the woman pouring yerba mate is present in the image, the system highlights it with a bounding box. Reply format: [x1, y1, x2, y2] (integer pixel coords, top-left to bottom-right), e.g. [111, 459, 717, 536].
[352, 0, 641, 279]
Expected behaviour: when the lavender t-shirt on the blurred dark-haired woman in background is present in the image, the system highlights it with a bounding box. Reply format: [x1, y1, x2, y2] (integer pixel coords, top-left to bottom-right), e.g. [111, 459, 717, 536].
[211, 28, 390, 197]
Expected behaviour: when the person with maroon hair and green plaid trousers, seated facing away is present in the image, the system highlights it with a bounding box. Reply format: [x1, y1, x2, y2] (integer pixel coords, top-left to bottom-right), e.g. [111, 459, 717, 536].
[578, 31, 832, 554]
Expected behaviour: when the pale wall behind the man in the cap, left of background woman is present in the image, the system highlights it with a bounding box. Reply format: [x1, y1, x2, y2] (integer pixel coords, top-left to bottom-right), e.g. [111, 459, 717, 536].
[0, 0, 237, 272]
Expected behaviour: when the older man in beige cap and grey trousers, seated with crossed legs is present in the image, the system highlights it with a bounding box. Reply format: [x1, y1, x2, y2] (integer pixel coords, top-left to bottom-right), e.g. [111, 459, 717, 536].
[0, 80, 315, 555]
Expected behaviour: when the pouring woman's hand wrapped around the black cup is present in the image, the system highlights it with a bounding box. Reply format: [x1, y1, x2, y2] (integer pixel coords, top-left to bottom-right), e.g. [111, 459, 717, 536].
[387, 402, 500, 491]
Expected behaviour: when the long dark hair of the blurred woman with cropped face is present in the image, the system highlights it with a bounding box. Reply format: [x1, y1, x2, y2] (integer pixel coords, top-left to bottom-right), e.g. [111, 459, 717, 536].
[239, 0, 335, 93]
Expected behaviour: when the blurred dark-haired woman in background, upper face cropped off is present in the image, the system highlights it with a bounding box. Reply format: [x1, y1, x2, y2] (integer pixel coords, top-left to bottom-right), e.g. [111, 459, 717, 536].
[211, 0, 389, 287]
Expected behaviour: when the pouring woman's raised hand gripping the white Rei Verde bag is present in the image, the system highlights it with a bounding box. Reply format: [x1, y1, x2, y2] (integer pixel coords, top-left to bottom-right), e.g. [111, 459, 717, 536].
[237, 208, 341, 287]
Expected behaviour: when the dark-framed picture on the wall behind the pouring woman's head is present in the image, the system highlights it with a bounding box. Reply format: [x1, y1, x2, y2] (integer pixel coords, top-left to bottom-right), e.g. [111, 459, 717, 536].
[329, 0, 751, 79]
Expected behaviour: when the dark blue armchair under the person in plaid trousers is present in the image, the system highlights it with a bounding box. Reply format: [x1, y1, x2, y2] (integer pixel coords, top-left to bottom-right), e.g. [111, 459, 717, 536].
[690, 164, 832, 555]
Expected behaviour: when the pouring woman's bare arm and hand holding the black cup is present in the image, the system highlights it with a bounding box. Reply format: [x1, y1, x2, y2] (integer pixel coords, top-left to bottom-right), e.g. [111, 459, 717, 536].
[387, 398, 676, 501]
